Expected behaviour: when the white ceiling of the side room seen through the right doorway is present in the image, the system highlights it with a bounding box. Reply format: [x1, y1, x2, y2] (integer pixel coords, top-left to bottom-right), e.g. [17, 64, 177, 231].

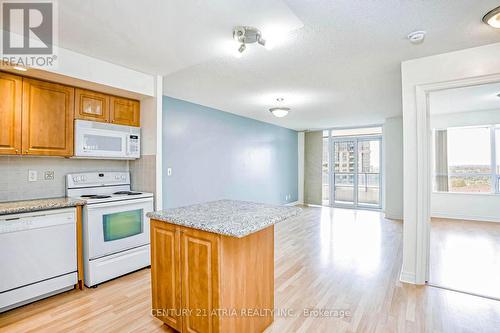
[429, 83, 500, 114]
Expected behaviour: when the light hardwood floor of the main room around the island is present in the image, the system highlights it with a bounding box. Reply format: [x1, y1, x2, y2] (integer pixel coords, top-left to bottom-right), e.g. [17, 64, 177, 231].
[0, 208, 500, 333]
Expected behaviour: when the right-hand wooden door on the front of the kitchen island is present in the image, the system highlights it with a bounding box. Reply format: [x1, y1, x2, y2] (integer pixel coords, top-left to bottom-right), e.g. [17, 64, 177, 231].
[181, 227, 219, 332]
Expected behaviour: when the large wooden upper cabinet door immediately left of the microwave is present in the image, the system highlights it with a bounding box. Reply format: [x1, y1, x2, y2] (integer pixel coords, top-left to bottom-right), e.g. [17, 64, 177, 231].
[22, 79, 75, 157]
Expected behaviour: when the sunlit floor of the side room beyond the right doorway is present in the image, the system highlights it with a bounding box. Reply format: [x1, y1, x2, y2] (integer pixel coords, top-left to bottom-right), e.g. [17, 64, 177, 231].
[429, 219, 500, 299]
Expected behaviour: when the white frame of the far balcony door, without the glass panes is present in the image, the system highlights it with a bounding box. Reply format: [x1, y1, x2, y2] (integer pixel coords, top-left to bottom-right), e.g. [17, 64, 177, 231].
[328, 134, 383, 211]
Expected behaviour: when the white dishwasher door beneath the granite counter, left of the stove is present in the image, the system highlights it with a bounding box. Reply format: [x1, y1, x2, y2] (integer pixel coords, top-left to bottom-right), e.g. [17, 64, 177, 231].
[0, 209, 77, 294]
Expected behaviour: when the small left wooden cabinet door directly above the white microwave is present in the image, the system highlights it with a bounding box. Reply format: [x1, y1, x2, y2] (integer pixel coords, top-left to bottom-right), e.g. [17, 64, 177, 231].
[75, 88, 110, 122]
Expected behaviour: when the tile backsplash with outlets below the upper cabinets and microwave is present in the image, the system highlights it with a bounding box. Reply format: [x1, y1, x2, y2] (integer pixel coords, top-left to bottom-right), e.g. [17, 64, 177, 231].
[0, 156, 129, 202]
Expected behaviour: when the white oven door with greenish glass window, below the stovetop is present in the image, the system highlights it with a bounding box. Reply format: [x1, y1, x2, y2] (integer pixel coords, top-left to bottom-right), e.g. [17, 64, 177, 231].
[83, 198, 153, 260]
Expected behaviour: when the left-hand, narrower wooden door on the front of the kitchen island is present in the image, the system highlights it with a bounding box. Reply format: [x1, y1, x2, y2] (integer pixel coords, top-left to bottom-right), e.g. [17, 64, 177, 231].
[151, 221, 182, 331]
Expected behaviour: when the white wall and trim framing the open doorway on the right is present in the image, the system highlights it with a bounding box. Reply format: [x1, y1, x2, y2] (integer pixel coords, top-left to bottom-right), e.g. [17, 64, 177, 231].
[401, 43, 500, 284]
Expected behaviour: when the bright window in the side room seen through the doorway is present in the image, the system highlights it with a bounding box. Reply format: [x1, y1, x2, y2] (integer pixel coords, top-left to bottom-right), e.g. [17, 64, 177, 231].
[434, 126, 500, 193]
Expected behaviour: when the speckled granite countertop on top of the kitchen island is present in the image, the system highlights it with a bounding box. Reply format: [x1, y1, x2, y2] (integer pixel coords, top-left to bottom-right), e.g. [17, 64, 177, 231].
[147, 200, 302, 238]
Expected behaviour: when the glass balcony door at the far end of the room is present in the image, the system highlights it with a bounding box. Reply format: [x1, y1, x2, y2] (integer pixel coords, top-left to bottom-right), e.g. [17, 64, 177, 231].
[330, 136, 382, 208]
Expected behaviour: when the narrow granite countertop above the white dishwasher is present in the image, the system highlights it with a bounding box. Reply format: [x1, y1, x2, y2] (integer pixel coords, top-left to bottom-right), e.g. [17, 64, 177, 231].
[0, 197, 85, 215]
